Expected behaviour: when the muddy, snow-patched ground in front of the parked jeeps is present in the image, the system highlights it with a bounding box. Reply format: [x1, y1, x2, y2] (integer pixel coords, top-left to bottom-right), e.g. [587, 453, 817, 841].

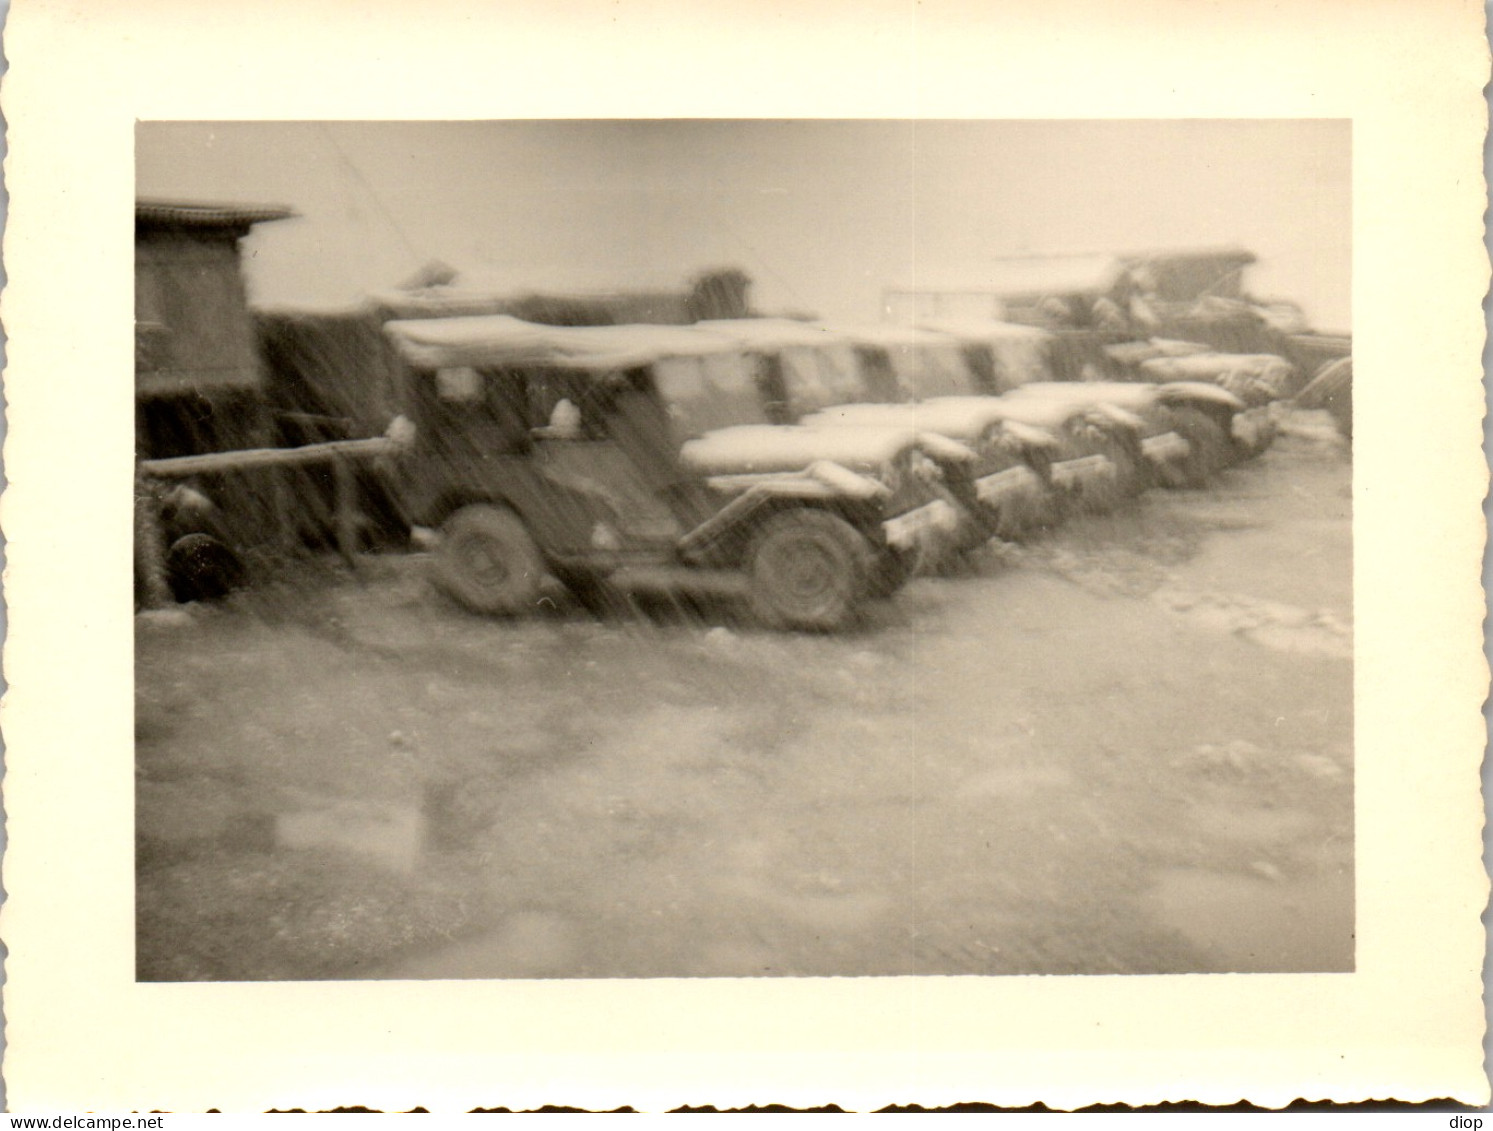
[136, 416, 1354, 979]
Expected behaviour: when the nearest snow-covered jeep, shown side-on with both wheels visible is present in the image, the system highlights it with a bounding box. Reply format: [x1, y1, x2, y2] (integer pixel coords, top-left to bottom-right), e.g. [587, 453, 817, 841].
[387, 315, 956, 630]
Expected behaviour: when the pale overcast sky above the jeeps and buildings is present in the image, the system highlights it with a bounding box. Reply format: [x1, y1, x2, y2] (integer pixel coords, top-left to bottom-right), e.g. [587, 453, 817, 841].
[136, 119, 1351, 330]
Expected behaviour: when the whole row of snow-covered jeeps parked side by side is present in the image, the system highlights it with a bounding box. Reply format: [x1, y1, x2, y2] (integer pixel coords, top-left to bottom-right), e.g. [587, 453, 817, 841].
[387, 315, 1291, 630]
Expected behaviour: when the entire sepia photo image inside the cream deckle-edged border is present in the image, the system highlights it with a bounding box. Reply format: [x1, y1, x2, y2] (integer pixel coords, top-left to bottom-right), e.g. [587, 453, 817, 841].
[134, 118, 1356, 982]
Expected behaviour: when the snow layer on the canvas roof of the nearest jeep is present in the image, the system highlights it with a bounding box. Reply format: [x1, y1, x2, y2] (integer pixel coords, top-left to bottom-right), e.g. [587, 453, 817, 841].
[384, 315, 735, 369]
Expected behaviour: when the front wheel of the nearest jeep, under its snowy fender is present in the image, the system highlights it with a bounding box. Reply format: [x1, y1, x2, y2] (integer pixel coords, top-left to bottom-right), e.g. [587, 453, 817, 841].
[747, 509, 875, 631]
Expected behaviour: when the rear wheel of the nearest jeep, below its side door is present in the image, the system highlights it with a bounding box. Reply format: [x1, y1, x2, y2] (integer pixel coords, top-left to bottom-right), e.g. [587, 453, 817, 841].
[434, 504, 545, 615]
